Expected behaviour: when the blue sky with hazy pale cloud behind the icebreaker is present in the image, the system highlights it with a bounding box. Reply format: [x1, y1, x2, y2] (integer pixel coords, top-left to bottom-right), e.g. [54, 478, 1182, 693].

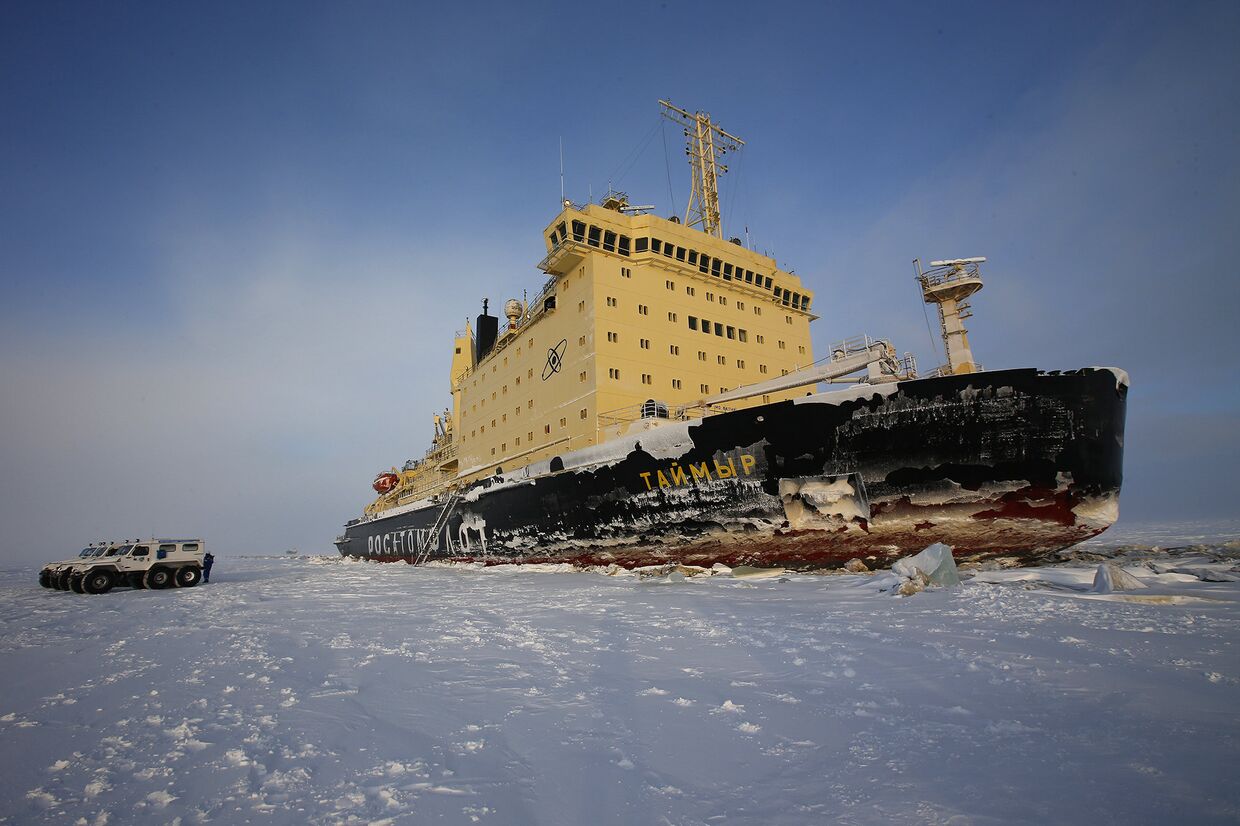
[0, 2, 1240, 558]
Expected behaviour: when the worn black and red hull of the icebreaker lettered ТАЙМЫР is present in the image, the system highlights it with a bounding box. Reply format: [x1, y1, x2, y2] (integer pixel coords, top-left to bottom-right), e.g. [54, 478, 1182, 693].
[336, 368, 1128, 568]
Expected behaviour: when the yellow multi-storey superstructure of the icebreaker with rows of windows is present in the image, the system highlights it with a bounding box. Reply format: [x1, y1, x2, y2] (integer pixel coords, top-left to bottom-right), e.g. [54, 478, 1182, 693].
[367, 102, 815, 513]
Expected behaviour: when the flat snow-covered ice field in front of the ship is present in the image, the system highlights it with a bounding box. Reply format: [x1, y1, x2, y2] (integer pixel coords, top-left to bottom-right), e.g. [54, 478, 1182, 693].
[0, 523, 1240, 825]
